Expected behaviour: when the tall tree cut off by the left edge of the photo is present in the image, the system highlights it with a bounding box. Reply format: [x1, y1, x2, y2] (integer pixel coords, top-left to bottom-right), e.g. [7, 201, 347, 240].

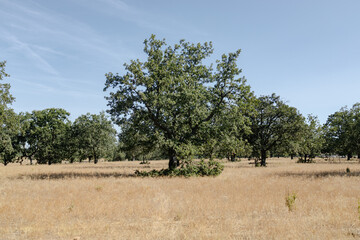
[0, 61, 18, 166]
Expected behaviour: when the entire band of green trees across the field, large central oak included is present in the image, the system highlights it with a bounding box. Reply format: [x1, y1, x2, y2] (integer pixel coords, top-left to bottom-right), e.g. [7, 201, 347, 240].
[0, 35, 360, 170]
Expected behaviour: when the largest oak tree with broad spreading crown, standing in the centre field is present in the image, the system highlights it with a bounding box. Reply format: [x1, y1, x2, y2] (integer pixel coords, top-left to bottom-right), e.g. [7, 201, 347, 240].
[104, 35, 250, 169]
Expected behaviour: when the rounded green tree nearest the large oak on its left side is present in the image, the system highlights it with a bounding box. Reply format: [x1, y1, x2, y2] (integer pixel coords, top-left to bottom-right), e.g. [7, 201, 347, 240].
[73, 112, 116, 164]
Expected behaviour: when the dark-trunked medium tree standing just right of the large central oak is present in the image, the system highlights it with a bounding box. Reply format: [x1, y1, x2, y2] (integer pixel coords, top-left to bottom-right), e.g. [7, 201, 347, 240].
[249, 94, 304, 166]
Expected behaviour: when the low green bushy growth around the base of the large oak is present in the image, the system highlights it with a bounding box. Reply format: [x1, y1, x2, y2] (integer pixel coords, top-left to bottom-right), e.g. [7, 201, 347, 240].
[135, 160, 224, 177]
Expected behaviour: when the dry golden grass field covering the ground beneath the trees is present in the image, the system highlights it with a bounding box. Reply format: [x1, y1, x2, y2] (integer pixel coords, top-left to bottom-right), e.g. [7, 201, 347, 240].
[0, 159, 360, 239]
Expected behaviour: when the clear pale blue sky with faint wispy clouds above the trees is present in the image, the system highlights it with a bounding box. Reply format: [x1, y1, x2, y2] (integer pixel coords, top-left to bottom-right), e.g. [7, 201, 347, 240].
[0, 0, 360, 123]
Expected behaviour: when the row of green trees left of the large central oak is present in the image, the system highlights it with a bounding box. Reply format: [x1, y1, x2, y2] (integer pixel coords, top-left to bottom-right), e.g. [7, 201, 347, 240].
[0, 61, 117, 166]
